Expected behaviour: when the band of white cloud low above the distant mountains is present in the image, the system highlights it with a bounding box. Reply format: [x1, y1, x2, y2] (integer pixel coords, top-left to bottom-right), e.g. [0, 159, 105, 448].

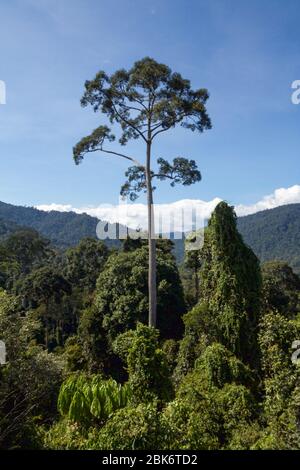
[36, 185, 300, 232]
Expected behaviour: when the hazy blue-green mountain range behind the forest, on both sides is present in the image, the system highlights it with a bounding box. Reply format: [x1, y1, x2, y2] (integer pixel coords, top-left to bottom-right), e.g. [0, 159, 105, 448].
[0, 202, 300, 272]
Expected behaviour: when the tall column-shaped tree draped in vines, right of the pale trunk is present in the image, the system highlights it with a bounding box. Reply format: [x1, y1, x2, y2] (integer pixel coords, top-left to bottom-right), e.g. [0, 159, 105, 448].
[200, 202, 261, 364]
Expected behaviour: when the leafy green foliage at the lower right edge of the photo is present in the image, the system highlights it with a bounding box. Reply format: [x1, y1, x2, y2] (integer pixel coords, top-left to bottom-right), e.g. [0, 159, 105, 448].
[256, 312, 300, 450]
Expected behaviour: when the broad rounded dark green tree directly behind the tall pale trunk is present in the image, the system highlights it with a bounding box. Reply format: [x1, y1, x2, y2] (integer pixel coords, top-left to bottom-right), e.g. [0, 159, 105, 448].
[80, 243, 185, 361]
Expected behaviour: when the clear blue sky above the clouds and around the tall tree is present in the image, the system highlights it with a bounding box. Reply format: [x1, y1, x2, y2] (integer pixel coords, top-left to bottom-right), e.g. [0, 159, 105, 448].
[0, 0, 300, 211]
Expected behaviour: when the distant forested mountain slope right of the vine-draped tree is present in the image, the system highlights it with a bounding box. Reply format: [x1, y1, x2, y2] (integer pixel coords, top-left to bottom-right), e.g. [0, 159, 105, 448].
[238, 204, 300, 273]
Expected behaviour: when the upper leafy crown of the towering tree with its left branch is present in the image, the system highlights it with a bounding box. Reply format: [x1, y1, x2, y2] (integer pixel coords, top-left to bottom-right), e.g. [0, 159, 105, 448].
[74, 57, 211, 164]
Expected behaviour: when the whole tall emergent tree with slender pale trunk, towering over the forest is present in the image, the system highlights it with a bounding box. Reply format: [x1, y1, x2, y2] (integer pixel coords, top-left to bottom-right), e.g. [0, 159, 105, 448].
[73, 57, 211, 326]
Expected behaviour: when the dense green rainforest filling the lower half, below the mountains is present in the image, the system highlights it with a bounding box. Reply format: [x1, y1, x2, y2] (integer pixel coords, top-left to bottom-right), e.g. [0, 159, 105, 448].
[0, 203, 300, 450]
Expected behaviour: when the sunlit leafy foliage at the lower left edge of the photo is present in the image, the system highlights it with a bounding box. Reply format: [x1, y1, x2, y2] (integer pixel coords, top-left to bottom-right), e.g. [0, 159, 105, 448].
[0, 291, 64, 449]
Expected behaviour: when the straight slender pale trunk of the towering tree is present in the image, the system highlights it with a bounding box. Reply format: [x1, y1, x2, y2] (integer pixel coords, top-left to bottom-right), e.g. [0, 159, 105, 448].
[146, 142, 157, 328]
